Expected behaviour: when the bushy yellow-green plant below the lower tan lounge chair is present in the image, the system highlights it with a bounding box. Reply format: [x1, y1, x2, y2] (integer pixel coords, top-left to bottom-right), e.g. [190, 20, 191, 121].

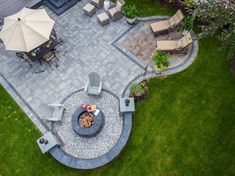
[152, 49, 170, 72]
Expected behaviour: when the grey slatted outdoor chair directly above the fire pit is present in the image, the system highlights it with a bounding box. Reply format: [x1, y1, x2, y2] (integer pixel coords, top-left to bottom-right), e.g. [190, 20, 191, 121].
[84, 72, 102, 95]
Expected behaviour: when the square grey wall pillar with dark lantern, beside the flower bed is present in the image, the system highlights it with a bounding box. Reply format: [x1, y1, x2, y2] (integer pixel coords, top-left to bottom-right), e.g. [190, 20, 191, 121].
[120, 98, 135, 113]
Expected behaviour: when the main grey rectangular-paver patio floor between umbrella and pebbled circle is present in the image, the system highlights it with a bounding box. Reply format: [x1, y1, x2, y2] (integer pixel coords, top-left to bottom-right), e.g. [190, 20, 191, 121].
[0, 1, 142, 129]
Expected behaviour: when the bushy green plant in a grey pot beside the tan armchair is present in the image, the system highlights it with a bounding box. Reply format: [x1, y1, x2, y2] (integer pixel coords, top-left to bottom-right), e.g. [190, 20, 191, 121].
[124, 5, 138, 24]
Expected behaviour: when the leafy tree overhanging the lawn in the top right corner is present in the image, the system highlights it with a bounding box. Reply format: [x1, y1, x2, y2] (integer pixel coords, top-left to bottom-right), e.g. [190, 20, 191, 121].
[195, 0, 235, 58]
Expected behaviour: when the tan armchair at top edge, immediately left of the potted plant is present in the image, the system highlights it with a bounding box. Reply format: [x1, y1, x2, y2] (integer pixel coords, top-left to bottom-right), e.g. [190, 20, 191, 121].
[108, 0, 125, 21]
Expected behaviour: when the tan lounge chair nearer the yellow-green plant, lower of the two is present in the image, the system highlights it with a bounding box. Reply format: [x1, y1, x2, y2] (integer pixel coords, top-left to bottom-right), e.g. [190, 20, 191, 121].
[157, 32, 193, 53]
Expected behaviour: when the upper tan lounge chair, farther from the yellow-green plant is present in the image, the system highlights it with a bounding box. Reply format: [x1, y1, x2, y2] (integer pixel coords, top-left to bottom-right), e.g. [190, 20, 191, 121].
[150, 10, 184, 37]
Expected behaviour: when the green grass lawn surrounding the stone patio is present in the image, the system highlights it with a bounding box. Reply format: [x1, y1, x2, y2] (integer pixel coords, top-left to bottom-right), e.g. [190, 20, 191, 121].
[0, 0, 235, 176]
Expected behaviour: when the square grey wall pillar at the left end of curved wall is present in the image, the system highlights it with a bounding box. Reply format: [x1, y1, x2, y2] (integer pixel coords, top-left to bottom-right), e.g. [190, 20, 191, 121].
[37, 132, 60, 153]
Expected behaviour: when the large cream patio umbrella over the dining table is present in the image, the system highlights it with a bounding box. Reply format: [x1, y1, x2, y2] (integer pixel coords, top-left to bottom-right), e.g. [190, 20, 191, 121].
[0, 8, 55, 52]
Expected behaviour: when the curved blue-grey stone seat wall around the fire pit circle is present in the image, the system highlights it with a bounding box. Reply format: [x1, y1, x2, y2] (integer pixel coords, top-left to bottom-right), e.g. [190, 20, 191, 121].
[49, 113, 132, 169]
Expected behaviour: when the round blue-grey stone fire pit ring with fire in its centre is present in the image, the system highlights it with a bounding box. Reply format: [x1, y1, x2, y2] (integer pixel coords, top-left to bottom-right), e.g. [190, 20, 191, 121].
[71, 106, 104, 138]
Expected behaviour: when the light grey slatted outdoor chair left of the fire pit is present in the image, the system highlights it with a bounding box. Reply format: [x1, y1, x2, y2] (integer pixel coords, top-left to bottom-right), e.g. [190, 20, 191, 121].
[40, 104, 65, 121]
